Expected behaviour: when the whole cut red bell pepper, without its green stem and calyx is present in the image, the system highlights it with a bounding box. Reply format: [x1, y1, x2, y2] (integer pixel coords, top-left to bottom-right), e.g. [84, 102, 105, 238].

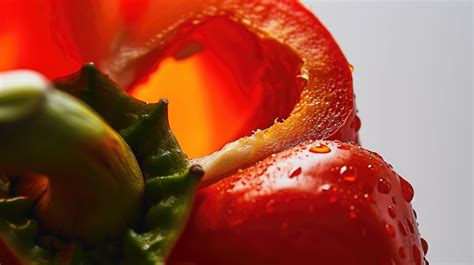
[0, 0, 426, 265]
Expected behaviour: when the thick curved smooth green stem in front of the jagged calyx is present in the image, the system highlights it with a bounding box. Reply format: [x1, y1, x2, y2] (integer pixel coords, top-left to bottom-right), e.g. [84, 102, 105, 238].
[0, 71, 144, 242]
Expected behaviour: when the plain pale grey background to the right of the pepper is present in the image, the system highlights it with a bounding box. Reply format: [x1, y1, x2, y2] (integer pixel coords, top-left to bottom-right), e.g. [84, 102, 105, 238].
[303, 1, 473, 264]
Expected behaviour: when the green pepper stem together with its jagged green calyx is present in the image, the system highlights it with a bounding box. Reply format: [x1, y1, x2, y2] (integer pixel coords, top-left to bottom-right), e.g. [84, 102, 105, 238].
[0, 64, 203, 265]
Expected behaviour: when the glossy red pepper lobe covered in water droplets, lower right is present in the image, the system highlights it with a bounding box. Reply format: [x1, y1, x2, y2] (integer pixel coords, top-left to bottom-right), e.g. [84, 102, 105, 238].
[168, 141, 423, 265]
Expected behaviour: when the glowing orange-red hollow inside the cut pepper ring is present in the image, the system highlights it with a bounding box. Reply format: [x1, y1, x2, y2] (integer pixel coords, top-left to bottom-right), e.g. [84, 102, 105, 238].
[131, 16, 303, 158]
